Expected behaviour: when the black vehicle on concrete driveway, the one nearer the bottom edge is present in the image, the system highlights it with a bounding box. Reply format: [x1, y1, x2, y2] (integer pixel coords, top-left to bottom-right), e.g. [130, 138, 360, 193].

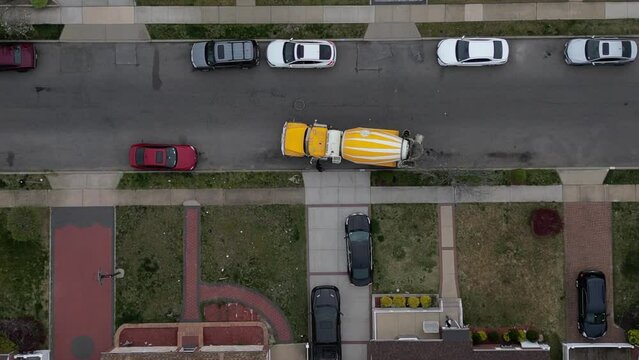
[311, 285, 342, 360]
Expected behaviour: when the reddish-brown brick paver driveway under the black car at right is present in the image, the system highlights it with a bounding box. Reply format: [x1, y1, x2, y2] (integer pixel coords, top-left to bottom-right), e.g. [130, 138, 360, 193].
[564, 203, 625, 342]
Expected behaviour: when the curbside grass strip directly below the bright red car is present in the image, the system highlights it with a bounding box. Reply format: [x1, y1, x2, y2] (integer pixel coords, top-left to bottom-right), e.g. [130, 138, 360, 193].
[118, 172, 304, 189]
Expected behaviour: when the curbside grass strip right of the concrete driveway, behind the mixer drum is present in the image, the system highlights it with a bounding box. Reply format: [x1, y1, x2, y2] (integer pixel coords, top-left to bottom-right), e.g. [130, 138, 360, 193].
[371, 169, 561, 186]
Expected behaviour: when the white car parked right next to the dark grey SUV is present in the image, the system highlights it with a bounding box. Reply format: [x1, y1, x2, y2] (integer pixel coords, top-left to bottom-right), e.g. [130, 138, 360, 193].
[266, 39, 337, 69]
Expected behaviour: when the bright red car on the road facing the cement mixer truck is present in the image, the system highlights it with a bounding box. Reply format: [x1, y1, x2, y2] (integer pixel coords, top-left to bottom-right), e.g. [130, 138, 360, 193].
[129, 144, 197, 171]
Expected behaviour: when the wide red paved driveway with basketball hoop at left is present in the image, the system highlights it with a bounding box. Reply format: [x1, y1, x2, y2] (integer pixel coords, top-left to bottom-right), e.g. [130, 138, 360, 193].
[52, 225, 113, 360]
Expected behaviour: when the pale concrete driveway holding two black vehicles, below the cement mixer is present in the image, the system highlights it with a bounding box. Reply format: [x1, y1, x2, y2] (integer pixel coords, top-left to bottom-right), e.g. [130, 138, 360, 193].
[304, 172, 371, 360]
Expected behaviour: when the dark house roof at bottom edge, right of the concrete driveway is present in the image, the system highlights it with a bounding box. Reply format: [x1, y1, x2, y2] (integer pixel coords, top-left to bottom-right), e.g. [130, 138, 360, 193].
[368, 341, 550, 360]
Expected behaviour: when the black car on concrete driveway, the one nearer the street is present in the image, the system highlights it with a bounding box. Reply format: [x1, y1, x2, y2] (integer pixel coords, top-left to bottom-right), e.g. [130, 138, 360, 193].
[345, 213, 373, 286]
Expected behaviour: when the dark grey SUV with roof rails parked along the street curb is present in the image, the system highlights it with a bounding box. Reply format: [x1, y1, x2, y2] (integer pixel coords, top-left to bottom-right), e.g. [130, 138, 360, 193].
[191, 40, 260, 70]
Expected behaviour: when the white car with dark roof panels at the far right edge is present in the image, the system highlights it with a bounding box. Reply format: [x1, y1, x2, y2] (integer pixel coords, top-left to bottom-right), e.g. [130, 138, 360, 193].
[564, 36, 637, 65]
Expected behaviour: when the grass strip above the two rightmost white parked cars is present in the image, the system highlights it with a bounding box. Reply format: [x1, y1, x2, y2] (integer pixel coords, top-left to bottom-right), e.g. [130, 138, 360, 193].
[417, 19, 639, 37]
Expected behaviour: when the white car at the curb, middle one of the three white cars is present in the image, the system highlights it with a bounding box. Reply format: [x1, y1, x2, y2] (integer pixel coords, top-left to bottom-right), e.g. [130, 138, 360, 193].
[437, 37, 508, 66]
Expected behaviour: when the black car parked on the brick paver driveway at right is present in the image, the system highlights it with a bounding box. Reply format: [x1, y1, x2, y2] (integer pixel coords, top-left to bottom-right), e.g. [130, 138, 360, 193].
[576, 270, 608, 339]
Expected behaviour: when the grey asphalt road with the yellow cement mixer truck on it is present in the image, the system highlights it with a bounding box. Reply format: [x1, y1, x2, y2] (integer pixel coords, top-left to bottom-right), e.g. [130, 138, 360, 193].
[0, 39, 639, 171]
